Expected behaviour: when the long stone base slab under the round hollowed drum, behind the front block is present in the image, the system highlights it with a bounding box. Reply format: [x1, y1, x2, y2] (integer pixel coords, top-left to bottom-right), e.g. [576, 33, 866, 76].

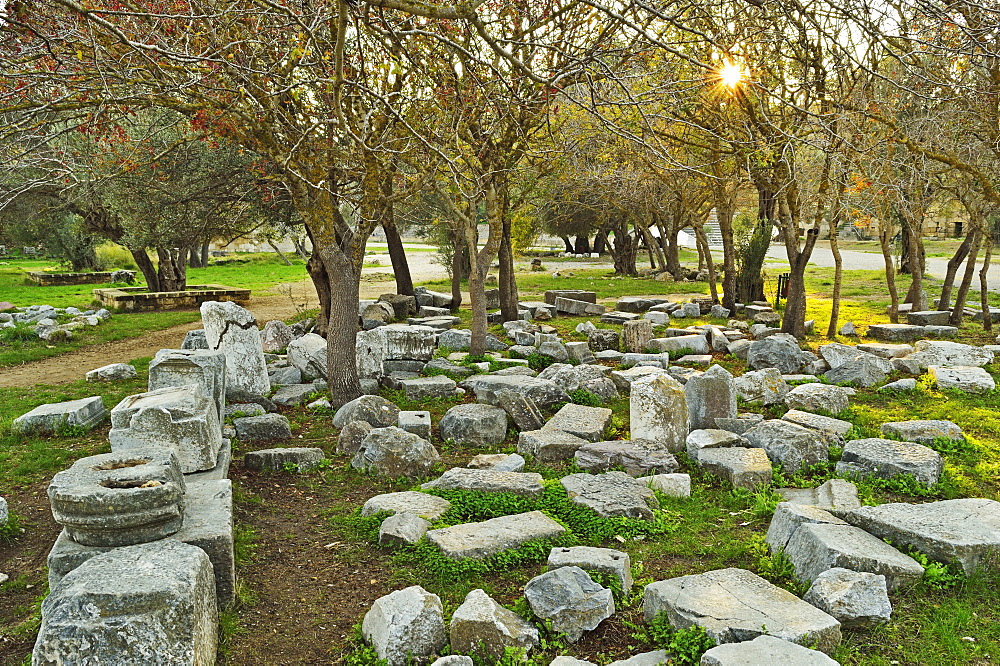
[48, 479, 236, 606]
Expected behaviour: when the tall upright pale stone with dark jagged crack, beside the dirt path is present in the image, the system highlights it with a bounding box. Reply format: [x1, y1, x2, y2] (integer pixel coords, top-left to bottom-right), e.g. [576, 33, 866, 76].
[201, 301, 271, 395]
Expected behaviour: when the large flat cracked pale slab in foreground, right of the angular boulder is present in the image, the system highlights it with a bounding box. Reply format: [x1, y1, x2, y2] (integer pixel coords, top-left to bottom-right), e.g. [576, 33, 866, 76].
[643, 569, 841, 652]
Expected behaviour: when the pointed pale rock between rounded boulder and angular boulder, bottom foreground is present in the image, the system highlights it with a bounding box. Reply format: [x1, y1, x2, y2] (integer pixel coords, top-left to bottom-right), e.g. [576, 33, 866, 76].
[448, 589, 539, 661]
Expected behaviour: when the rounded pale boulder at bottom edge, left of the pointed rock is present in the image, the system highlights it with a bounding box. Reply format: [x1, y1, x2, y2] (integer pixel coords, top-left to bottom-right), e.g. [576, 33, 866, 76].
[361, 585, 448, 666]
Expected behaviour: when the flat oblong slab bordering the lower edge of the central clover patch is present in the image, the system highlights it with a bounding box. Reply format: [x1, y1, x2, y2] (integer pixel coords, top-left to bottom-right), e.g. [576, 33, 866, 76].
[427, 511, 566, 559]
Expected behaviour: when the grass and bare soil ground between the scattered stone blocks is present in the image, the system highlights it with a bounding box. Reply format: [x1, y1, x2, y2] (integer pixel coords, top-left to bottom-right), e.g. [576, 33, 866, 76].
[0, 269, 1000, 666]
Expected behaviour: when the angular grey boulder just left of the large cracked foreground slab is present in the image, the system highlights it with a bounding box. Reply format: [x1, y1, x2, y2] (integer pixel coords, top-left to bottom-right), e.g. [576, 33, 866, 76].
[524, 566, 615, 643]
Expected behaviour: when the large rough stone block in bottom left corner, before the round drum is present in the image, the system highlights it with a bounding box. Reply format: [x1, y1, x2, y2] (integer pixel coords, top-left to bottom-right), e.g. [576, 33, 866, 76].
[32, 539, 218, 664]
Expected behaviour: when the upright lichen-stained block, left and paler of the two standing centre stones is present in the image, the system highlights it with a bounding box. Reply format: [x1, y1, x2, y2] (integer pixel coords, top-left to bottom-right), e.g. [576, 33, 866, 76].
[629, 374, 688, 452]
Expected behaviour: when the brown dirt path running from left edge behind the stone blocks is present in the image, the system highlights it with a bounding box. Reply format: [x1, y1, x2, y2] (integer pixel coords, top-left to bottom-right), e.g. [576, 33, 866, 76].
[0, 252, 445, 387]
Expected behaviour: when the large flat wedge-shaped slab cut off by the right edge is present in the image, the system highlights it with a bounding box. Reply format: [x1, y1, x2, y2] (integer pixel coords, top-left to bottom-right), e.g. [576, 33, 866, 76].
[844, 499, 1000, 573]
